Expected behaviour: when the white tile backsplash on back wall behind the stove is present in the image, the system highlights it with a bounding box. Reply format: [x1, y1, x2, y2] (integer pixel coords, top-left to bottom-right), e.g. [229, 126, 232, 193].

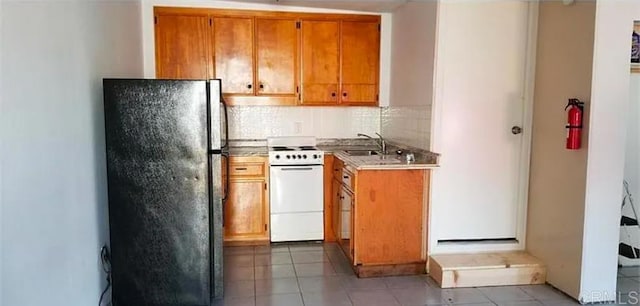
[229, 106, 381, 139]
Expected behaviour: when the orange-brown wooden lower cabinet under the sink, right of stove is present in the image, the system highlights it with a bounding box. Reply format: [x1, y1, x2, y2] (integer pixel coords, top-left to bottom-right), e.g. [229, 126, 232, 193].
[332, 157, 430, 277]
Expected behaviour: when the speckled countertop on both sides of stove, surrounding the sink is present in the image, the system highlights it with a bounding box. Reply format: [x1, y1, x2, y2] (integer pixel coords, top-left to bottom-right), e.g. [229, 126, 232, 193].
[229, 139, 439, 170]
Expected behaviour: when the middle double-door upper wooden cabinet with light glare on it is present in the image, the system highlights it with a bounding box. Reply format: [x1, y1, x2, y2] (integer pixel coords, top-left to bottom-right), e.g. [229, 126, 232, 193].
[213, 16, 298, 104]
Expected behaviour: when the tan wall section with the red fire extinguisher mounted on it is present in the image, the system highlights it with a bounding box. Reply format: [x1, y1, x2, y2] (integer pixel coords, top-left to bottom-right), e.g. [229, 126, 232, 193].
[526, 1, 596, 298]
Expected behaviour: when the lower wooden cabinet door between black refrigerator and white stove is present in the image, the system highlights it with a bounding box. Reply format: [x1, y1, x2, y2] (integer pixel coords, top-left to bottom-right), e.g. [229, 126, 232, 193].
[224, 179, 269, 241]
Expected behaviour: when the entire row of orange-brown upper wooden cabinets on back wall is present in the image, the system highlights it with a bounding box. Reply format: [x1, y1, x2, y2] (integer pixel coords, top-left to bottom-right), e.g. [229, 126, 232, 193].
[154, 7, 380, 106]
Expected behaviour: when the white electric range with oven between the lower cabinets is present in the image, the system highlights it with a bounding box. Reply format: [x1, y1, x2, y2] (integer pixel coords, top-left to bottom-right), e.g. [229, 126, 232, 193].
[267, 137, 324, 242]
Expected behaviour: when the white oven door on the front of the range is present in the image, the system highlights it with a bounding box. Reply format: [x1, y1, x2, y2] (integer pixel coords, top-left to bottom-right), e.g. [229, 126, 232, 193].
[269, 165, 324, 214]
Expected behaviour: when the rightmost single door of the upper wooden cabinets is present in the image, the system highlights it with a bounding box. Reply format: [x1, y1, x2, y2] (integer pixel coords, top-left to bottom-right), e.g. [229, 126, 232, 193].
[340, 21, 380, 105]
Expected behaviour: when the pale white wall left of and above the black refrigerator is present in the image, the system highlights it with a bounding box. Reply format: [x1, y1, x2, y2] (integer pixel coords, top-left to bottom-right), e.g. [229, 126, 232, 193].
[0, 0, 142, 306]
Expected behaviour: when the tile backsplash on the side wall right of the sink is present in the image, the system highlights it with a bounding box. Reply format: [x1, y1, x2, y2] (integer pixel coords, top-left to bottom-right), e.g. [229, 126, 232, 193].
[381, 105, 431, 150]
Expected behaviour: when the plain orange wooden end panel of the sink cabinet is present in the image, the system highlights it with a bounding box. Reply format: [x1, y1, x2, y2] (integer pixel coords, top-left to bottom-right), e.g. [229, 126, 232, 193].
[352, 170, 425, 264]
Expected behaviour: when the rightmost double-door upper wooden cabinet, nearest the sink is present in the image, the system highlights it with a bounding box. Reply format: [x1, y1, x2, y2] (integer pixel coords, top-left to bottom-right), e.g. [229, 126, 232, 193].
[301, 20, 380, 106]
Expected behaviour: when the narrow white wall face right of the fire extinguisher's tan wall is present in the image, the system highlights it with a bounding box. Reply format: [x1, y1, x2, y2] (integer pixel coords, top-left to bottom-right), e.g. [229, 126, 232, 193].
[580, 0, 640, 302]
